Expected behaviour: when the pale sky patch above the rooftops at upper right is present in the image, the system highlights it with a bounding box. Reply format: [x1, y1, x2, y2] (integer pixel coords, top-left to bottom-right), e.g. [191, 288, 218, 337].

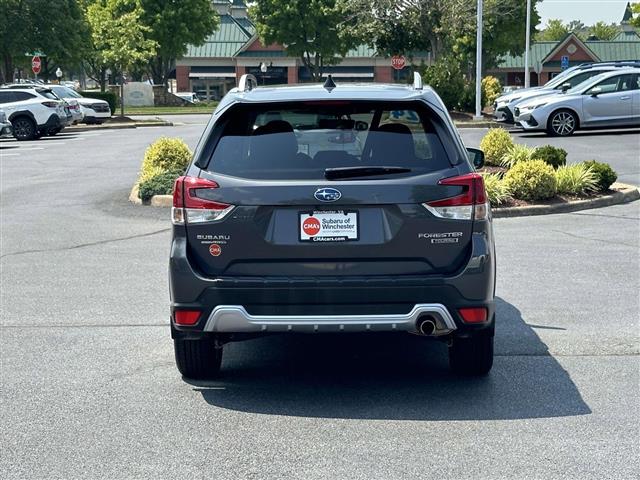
[536, 0, 628, 25]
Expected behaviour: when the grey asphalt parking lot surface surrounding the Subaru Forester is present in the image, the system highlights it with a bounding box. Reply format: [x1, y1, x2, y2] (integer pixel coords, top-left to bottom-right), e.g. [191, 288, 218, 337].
[0, 121, 640, 480]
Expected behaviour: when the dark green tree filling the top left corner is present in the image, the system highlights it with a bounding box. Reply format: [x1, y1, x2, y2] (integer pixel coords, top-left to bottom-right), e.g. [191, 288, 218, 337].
[0, 0, 88, 81]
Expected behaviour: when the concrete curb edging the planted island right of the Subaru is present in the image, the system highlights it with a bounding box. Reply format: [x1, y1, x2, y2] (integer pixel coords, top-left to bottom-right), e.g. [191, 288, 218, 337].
[492, 183, 640, 218]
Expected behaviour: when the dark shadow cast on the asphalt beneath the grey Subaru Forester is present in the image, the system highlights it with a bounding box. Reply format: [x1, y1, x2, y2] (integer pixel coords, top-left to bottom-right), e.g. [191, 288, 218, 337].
[187, 299, 591, 420]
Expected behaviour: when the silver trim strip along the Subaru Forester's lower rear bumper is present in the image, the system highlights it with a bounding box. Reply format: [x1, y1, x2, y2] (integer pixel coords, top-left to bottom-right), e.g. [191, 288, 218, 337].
[204, 303, 456, 335]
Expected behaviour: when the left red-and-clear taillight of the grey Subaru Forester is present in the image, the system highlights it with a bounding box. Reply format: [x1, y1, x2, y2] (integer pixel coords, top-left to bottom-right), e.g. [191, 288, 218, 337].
[171, 176, 235, 225]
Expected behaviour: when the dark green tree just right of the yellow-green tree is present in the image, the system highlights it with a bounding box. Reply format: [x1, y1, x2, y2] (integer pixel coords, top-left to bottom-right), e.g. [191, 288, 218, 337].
[140, 0, 219, 84]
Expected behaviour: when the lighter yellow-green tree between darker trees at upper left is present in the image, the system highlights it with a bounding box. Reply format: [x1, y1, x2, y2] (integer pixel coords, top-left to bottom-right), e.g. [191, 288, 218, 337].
[86, 0, 157, 91]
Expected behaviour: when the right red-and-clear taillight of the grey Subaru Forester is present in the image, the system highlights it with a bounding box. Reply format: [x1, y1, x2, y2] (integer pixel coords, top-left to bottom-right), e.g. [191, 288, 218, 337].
[422, 173, 490, 220]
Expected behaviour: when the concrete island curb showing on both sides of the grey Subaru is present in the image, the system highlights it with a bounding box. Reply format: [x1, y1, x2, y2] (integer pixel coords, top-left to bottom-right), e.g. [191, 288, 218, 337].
[129, 183, 640, 218]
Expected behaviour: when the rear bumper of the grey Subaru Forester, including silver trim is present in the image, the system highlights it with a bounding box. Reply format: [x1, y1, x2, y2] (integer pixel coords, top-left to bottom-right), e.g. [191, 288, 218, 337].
[169, 233, 495, 338]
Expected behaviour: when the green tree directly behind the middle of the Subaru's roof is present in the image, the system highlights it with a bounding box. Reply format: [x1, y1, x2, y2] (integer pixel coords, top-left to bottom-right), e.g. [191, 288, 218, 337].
[249, 0, 355, 81]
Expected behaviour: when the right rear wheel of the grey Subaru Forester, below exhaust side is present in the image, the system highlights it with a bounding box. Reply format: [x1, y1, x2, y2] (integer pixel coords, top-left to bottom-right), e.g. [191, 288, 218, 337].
[449, 333, 493, 376]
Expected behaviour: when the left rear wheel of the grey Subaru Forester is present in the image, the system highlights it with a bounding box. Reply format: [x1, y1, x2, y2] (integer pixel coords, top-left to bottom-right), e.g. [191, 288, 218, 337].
[173, 338, 222, 379]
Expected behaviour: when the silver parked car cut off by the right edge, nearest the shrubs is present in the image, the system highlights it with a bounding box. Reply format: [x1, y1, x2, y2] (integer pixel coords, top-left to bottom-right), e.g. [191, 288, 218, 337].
[515, 68, 640, 136]
